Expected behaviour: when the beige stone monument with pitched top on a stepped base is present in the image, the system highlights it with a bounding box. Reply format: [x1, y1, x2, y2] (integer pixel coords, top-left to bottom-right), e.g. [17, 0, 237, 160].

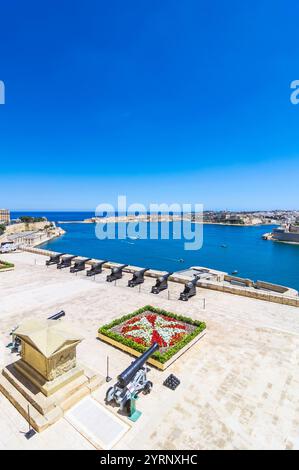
[0, 319, 101, 431]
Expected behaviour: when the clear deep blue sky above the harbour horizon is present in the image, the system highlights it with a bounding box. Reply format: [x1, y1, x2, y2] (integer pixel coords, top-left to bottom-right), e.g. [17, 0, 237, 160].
[0, 0, 299, 210]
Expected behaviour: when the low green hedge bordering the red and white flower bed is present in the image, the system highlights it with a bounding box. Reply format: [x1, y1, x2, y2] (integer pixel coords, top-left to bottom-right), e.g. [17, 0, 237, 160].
[98, 305, 206, 364]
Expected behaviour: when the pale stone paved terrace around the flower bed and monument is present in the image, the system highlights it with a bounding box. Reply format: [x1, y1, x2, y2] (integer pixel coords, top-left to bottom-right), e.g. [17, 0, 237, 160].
[0, 253, 299, 449]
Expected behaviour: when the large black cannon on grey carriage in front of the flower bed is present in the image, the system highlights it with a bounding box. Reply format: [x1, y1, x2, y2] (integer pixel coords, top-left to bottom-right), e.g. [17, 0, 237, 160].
[106, 343, 159, 414]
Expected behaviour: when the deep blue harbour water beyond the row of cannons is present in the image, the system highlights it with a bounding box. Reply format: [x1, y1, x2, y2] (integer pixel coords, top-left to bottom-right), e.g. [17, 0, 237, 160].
[12, 212, 299, 289]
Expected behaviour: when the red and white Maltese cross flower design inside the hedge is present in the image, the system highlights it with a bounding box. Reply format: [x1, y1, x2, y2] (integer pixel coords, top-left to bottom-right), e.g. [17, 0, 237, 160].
[121, 314, 187, 348]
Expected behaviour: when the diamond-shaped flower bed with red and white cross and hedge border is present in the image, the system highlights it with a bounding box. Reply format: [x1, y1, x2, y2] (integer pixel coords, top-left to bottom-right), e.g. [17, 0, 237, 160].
[99, 305, 206, 365]
